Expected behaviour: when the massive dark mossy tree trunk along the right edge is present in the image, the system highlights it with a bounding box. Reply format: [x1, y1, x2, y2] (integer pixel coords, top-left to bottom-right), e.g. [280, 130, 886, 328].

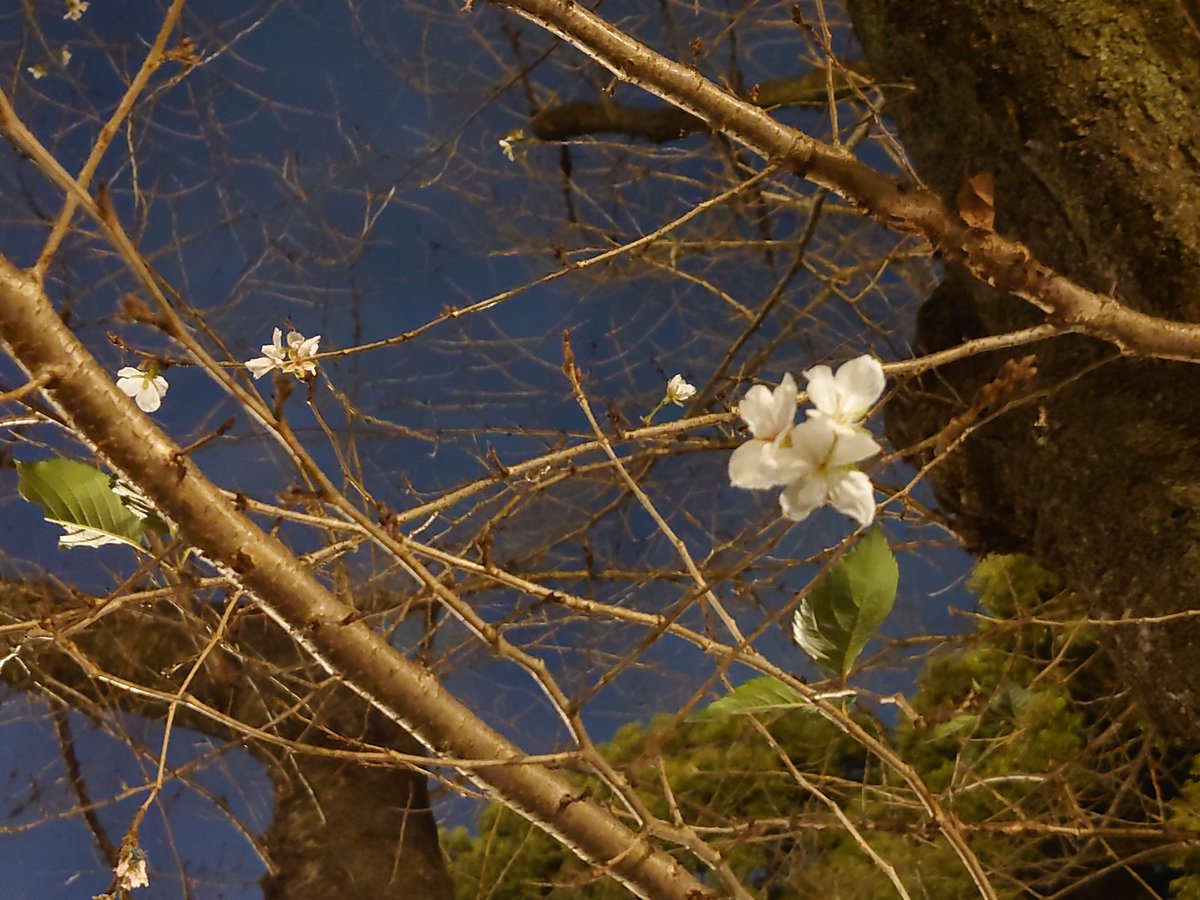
[850, 0, 1200, 739]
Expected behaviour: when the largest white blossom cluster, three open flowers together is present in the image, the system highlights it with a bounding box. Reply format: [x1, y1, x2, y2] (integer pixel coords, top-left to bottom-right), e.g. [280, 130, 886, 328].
[730, 355, 886, 526]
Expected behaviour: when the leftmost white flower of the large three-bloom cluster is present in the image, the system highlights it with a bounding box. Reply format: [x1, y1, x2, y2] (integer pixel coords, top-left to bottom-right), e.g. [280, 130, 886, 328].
[730, 374, 803, 490]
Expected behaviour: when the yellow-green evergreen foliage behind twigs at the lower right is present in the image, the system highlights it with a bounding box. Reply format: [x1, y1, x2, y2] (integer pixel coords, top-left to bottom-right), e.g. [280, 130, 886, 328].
[445, 556, 1200, 900]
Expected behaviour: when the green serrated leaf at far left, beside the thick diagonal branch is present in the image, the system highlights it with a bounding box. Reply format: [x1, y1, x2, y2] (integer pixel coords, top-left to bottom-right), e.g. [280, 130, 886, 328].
[17, 456, 166, 550]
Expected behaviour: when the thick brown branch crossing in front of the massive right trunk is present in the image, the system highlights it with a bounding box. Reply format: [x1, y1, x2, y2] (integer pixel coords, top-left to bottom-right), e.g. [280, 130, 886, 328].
[494, 0, 1200, 362]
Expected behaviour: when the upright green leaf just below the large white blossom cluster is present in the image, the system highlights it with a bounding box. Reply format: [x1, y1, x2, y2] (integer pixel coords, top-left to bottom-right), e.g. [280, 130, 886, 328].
[792, 528, 900, 678]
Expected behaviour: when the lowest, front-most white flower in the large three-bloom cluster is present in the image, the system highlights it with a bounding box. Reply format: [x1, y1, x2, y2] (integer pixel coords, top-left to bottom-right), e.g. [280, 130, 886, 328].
[779, 416, 881, 526]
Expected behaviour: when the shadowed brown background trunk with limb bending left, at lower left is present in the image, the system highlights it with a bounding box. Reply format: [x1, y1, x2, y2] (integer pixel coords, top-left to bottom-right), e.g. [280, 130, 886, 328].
[0, 581, 454, 900]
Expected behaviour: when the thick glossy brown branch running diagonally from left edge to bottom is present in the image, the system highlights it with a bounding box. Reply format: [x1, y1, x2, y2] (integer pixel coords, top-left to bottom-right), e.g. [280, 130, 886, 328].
[0, 258, 708, 900]
